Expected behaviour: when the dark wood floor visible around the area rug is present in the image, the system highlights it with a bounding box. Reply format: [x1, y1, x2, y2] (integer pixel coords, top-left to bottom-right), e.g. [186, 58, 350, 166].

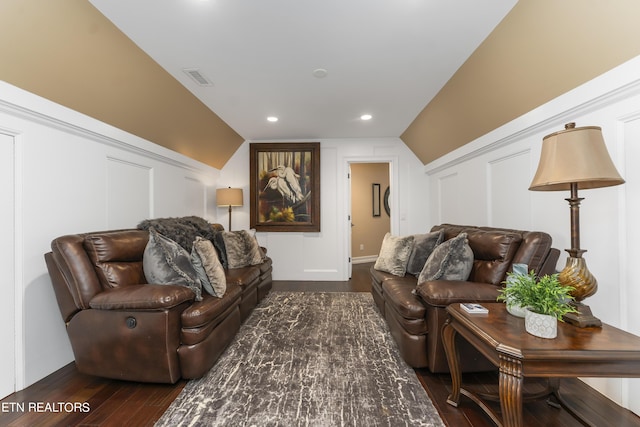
[0, 264, 640, 427]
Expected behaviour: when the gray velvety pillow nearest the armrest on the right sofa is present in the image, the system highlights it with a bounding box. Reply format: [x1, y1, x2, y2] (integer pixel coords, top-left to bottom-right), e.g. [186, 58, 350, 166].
[418, 233, 473, 283]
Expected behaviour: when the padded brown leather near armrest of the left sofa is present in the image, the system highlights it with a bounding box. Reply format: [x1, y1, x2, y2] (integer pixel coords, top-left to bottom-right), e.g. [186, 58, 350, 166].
[89, 285, 195, 310]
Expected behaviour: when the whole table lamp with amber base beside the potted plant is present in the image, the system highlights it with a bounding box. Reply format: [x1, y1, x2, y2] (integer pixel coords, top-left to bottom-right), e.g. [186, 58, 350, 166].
[529, 123, 624, 327]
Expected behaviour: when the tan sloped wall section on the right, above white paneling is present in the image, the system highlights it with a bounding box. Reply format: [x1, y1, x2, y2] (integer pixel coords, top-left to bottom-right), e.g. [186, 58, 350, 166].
[401, 0, 640, 164]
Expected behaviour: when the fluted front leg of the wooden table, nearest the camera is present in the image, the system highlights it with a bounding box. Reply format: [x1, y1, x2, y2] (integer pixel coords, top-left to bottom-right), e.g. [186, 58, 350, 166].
[499, 354, 523, 427]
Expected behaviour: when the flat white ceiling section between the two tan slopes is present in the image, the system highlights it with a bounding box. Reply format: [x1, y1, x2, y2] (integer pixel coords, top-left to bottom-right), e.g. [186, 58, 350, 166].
[90, 0, 515, 145]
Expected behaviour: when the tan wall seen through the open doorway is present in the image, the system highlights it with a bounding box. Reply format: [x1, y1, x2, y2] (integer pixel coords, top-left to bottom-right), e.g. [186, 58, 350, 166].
[351, 163, 390, 258]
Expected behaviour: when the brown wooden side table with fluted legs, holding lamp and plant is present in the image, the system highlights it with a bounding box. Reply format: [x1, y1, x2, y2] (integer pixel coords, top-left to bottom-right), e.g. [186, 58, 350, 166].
[442, 303, 640, 427]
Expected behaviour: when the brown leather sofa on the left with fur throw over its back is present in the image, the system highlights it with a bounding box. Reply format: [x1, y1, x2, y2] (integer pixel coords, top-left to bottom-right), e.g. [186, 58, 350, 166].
[45, 224, 272, 383]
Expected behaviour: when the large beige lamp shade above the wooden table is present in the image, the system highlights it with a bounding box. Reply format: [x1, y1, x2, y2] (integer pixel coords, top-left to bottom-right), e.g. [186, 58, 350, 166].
[529, 123, 624, 191]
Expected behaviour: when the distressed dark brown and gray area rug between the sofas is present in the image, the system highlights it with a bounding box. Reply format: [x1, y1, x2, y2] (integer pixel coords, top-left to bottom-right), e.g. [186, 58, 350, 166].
[156, 292, 444, 427]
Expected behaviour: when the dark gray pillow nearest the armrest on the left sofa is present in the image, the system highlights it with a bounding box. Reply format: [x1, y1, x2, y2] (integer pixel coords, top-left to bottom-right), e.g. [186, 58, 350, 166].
[142, 228, 202, 301]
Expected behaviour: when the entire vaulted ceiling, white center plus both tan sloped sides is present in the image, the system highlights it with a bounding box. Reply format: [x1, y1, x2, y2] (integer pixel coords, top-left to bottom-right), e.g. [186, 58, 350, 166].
[0, 0, 640, 168]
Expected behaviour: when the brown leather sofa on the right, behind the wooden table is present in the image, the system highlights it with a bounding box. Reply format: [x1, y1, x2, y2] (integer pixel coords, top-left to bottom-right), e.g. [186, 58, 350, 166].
[370, 224, 560, 373]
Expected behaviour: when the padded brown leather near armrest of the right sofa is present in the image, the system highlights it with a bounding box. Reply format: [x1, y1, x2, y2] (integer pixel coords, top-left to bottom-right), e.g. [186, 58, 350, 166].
[416, 280, 501, 307]
